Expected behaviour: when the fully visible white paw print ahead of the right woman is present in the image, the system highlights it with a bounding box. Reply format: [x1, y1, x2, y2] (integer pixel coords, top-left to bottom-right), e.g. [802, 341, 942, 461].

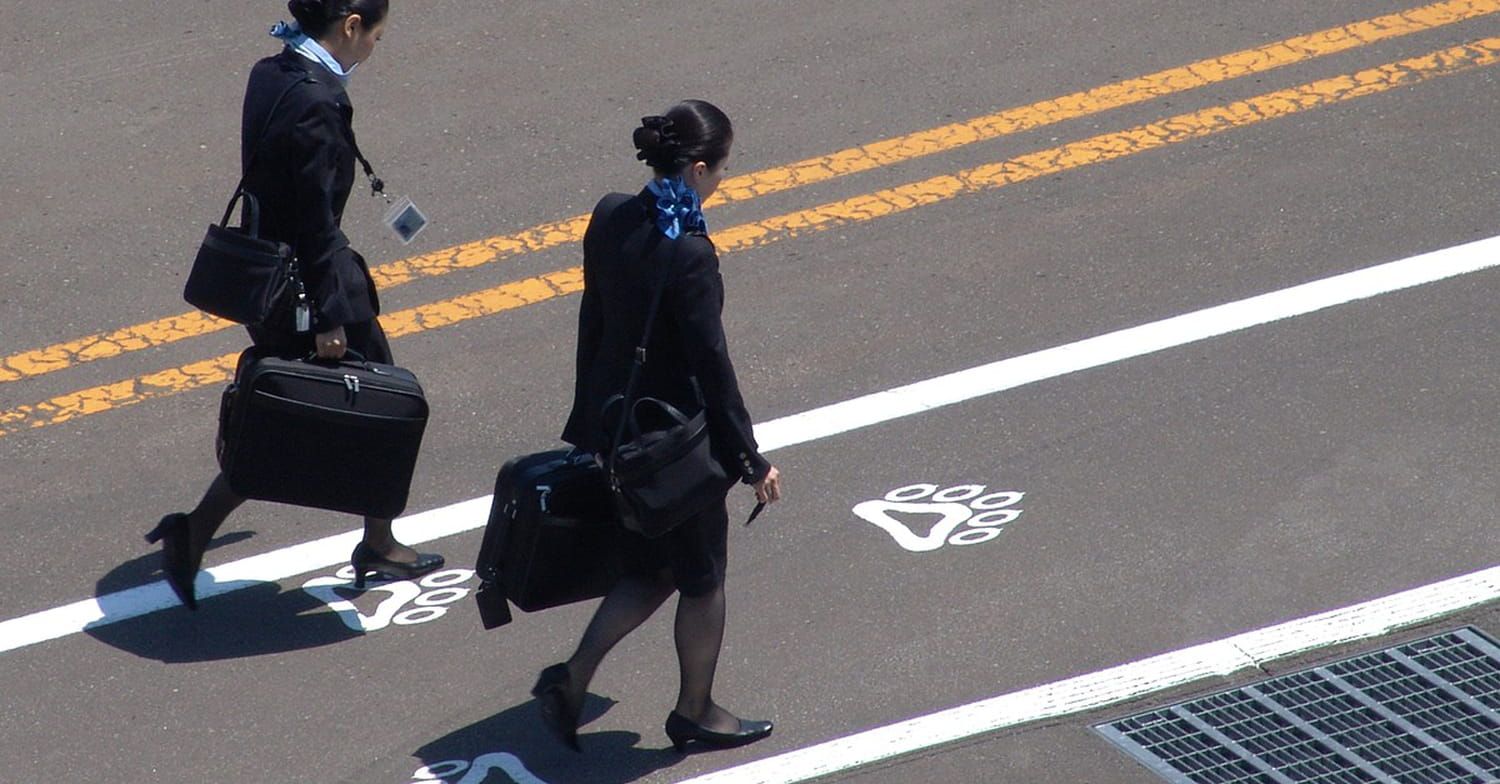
[854, 483, 1026, 553]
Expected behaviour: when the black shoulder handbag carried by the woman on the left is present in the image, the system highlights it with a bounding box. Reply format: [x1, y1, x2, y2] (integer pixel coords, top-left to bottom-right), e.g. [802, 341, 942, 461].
[183, 79, 311, 331]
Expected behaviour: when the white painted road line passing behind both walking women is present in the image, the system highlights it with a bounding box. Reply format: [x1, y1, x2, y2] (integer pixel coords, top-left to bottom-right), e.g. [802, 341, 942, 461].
[0, 237, 1500, 654]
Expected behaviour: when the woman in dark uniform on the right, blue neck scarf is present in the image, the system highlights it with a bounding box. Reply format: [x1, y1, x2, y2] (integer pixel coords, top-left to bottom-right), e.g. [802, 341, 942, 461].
[533, 100, 782, 751]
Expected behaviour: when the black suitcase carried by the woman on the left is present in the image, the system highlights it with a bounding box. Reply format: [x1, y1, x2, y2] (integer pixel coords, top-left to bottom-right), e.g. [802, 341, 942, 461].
[219, 348, 428, 519]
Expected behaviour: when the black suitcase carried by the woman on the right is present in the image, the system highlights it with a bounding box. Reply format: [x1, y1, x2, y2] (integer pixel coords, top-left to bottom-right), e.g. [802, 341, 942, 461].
[474, 450, 620, 628]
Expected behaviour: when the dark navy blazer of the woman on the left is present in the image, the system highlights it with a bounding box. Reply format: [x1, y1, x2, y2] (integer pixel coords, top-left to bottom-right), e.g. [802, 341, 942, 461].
[240, 49, 380, 333]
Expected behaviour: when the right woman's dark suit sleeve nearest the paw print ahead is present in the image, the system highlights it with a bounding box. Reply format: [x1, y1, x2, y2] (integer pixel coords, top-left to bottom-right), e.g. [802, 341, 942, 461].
[663, 237, 771, 484]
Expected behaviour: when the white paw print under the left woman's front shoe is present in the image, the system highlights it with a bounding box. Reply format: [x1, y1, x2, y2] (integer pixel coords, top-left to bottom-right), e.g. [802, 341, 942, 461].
[302, 567, 474, 631]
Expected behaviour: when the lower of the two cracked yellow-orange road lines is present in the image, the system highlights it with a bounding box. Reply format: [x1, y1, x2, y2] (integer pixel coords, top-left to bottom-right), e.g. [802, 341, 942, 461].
[0, 37, 1500, 436]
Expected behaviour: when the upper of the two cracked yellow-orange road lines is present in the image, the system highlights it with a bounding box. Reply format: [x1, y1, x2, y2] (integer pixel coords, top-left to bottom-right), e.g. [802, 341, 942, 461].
[0, 0, 1500, 384]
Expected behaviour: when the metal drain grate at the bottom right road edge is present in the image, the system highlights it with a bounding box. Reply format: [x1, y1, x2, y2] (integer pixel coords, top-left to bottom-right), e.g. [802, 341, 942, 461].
[1095, 628, 1500, 784]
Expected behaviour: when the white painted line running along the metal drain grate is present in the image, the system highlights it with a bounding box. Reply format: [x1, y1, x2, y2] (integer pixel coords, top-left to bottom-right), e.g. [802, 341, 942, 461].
[683, 567, 1500, 784]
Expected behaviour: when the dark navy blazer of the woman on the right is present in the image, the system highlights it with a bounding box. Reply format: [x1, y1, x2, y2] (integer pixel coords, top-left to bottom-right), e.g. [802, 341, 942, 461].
[563, 190, 771, 483]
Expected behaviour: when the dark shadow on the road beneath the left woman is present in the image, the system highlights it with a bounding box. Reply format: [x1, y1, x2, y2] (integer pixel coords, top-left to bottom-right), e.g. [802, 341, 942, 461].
[84, 531, 363, 663]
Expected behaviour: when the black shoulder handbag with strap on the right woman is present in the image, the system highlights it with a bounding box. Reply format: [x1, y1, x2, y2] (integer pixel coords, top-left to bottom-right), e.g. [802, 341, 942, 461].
[603, 235, 735, 538]
